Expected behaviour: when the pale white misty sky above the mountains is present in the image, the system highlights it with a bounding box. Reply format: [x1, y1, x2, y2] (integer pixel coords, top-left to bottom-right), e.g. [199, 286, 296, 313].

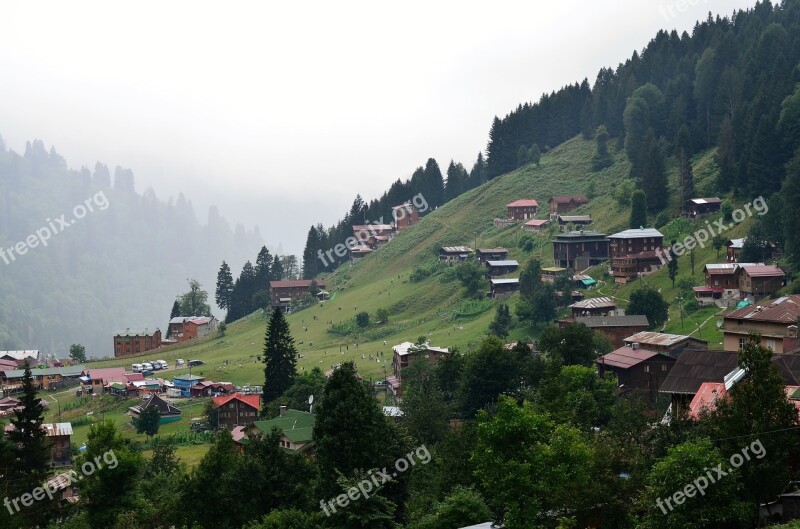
[0, 0, 755, 254]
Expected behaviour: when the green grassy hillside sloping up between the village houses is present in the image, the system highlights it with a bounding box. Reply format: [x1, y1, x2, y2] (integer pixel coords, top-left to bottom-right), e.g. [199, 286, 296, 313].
[70, 132, 776, 458]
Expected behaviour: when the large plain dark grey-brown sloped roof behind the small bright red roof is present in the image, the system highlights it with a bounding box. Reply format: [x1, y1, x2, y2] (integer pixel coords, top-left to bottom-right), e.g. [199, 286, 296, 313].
[658, 349, 738, 395]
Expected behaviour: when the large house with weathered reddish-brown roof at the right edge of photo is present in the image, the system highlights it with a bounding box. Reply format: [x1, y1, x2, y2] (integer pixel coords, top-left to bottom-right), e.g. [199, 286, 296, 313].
[722, 295, 800, 354]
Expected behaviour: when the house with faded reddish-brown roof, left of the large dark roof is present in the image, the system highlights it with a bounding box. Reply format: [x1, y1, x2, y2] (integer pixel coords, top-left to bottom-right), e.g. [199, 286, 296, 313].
[595, 343, 675, 403]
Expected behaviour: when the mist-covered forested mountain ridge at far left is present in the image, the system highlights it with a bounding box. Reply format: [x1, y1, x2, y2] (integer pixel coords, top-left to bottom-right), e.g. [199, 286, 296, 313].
[0, 139, 263, 356]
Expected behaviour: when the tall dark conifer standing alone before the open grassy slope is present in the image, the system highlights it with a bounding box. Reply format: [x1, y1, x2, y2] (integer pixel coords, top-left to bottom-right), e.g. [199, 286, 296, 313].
[262, 307, 297, 408]
